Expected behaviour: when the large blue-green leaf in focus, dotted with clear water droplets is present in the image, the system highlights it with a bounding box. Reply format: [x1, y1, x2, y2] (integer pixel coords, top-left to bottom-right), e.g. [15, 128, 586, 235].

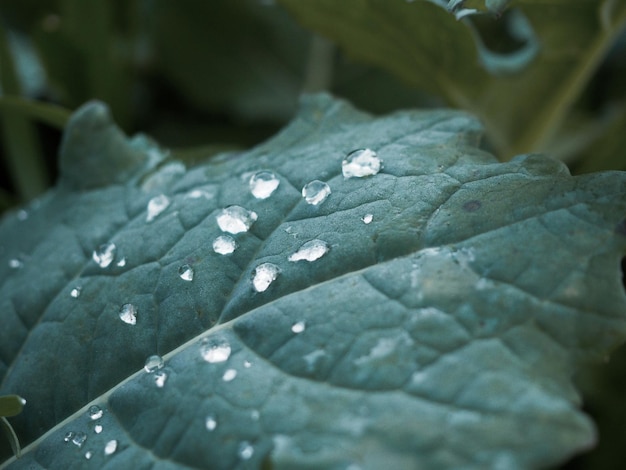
[0, 95, 626, 469]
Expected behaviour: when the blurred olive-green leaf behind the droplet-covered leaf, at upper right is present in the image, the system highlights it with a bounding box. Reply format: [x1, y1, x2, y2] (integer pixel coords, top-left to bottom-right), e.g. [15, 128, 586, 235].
[280, 0, 626, 159]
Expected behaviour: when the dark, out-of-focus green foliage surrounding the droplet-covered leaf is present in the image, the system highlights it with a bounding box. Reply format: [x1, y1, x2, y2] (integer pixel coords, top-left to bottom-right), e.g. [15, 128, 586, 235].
[0, 0, 626, 469]
